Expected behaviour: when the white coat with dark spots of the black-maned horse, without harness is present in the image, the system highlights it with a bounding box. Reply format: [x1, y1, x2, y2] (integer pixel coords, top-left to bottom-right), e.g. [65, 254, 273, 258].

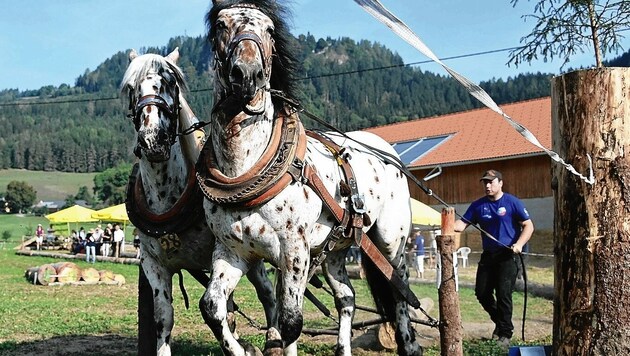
[201, 0, 422, 355]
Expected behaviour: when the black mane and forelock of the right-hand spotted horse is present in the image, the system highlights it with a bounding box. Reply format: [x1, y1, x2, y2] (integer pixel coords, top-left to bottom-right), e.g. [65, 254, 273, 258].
[206, 0, 298, 98]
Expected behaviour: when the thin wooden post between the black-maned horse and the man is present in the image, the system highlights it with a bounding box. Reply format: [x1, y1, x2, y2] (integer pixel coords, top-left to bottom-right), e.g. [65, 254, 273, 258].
[437, 208, 464, 356]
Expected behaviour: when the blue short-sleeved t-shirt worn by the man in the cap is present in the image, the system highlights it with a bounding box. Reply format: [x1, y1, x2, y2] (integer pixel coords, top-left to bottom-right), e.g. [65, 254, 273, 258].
[462, 193, 530, 252]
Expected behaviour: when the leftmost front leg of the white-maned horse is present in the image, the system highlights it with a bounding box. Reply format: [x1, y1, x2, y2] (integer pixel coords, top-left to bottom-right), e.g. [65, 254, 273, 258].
[141, 254, 174, 356]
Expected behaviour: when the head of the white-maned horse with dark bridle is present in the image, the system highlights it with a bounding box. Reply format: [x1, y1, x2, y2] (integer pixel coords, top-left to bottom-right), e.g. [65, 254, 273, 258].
[121, 48, 185, 162]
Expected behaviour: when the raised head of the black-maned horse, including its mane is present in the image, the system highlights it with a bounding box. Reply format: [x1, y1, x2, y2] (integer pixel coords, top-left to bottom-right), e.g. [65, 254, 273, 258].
[206, 0, 297, 114]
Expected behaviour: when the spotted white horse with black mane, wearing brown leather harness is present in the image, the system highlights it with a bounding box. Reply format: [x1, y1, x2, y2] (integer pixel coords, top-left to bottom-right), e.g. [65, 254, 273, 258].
[197, 0, 422, 355]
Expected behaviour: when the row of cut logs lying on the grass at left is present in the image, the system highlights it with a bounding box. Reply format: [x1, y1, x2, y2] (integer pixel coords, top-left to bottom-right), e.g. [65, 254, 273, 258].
[24, 262, 125, 286]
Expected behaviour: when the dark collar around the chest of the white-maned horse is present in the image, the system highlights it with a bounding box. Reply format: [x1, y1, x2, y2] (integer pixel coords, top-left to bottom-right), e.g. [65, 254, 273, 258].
[125, 163, 204, 237]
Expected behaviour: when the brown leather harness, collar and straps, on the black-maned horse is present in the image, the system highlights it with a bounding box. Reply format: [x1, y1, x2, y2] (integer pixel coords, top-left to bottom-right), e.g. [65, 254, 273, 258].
[197, 108, 420, 308]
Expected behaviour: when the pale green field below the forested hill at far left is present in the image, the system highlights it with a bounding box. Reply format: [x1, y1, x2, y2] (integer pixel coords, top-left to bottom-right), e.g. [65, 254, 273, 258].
[0, 169, 96, 201]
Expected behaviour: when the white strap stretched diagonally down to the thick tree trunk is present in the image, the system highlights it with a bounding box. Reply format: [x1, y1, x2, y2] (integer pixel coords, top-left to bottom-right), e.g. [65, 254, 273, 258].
[354, 0, 595, 185]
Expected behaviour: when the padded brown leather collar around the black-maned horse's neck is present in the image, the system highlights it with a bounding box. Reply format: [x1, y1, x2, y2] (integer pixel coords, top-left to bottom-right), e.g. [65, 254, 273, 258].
[197, 109, 306, 208]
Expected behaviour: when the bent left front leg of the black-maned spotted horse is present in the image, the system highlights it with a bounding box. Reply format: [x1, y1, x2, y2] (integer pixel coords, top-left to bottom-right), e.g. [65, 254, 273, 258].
[199, 248, 257, 356]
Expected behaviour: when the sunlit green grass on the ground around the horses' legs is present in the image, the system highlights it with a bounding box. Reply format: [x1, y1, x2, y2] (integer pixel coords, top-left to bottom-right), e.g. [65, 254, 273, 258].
[0, 249, 552, 355]
